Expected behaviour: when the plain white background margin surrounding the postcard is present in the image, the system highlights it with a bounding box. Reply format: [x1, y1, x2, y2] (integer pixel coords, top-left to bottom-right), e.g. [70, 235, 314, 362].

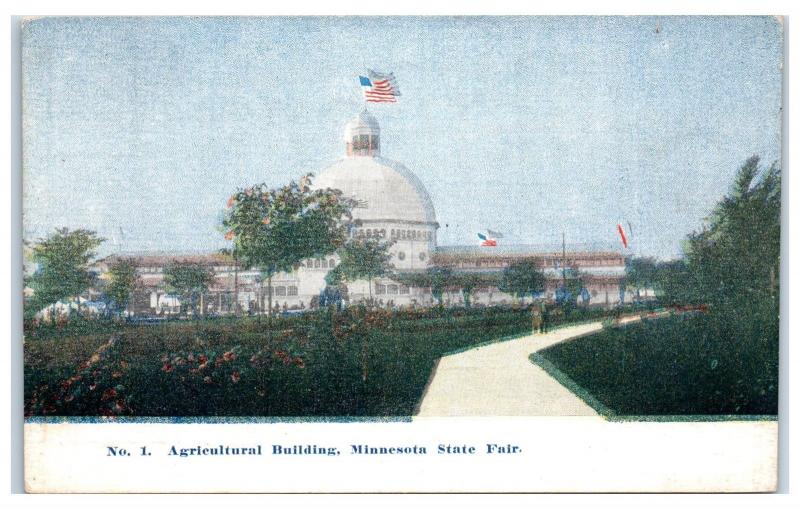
[0, 0, 800, 507]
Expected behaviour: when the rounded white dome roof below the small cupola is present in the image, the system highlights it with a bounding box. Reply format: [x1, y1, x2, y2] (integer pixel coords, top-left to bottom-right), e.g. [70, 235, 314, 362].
[313, 157, 436, 226]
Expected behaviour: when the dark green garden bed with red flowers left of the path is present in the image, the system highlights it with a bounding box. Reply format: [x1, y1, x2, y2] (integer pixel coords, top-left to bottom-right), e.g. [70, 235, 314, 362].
[25, 306, 556, 418]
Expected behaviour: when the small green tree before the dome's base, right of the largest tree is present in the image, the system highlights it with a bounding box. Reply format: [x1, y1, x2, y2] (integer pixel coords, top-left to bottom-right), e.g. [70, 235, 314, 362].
[328, 239, 392, 305]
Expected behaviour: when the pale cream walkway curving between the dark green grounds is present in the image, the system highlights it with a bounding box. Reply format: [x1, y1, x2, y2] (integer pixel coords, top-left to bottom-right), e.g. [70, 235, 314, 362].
[417, 317, 638, 417]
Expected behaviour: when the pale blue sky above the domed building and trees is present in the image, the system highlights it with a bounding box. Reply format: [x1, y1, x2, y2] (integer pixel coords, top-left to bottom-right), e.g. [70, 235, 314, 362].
[23, 17, 783, 258]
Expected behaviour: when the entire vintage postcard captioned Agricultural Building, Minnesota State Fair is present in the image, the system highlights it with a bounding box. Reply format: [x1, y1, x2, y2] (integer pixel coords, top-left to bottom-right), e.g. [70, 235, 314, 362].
[20, 16, 784, 493]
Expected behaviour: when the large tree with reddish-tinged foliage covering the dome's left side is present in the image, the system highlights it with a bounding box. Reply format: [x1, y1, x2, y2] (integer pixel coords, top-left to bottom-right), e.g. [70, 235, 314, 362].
[222, 174, 354, 329]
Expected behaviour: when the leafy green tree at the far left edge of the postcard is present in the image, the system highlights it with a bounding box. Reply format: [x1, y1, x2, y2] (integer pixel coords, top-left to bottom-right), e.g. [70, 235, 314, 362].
[27, 228, 103, 320]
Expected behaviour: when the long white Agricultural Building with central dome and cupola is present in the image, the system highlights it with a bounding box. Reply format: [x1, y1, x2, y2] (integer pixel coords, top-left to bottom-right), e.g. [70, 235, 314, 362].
[96, 110, 625, 314]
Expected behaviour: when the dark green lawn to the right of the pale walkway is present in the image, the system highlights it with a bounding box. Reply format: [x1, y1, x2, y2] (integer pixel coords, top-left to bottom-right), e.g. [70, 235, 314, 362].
[538, 315, 778, 416]
